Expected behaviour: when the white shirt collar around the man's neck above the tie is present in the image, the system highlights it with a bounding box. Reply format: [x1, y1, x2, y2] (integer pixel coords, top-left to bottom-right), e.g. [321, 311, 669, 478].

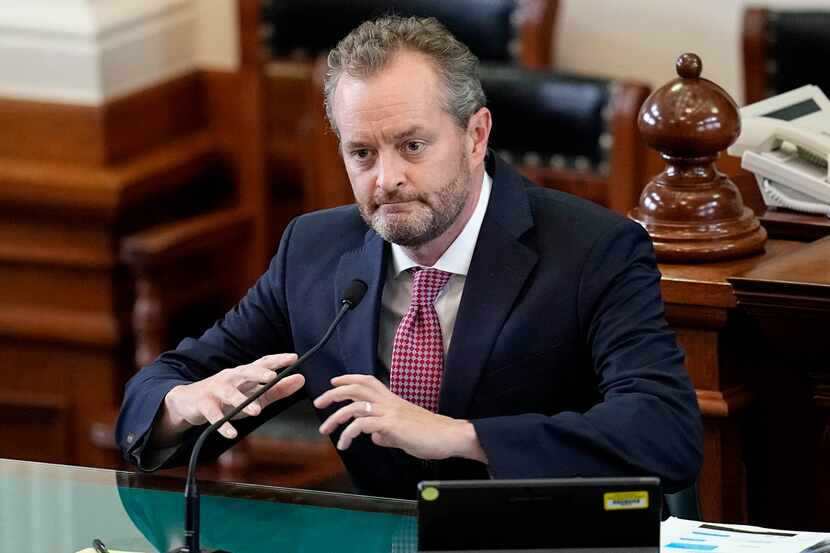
[392, 172, 493, 278]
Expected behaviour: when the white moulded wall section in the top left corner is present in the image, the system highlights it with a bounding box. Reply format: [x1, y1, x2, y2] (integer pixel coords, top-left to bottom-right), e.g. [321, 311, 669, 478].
[0, 0, 239, 105]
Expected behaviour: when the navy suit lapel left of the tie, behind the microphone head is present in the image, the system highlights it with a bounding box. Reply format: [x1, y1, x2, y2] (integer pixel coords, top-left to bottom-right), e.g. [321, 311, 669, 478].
[334, 231, 386, 374]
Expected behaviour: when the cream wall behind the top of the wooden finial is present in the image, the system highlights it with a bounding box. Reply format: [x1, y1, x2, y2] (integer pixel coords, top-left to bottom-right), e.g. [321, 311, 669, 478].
[555, 0, 830, 103]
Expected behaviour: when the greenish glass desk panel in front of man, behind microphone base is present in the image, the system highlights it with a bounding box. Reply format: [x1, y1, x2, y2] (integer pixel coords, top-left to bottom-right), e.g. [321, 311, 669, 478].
[0, 459, 417, 553]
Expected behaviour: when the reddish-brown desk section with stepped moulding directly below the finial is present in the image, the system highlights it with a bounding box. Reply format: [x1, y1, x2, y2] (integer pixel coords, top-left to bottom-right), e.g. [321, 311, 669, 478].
[660, 240, 803, 522]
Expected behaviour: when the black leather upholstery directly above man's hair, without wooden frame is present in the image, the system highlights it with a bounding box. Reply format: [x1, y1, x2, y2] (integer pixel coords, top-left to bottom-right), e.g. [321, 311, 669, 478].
[263, 0, 519, 62]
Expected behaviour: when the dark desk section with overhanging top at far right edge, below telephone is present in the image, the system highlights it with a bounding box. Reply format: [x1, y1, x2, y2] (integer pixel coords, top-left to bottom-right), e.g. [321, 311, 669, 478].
[729, 237, 830, 530]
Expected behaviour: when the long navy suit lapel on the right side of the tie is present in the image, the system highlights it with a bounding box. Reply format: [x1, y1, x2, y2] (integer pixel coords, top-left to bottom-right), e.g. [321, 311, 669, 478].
[439, 154, 538, 418]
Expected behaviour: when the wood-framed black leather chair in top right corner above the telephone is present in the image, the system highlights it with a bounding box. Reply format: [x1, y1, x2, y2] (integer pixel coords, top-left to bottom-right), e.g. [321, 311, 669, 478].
[743, 7, 830, 104]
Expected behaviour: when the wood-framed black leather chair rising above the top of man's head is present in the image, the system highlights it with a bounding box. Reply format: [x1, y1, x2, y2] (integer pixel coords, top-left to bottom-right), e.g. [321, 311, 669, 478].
[263, 0, 559, 216]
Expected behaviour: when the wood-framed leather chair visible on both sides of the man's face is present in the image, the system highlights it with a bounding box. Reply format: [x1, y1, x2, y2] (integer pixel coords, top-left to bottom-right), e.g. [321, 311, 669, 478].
[305, 59, 649, 214]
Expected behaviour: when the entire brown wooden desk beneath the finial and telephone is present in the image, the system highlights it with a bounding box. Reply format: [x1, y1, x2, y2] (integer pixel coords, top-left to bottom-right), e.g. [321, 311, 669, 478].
[660, 234, 830, 530]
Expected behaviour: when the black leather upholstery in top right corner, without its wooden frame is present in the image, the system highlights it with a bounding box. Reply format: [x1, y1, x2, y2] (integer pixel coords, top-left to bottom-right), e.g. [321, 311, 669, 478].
[765, 10, 830, 95]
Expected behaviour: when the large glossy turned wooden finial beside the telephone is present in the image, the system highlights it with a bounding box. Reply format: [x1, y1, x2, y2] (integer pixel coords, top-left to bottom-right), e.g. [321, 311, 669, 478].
[629, 53, 766, 261]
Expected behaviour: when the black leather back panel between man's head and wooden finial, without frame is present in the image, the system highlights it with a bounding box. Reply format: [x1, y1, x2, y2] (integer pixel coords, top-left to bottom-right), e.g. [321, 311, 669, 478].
[481, 66, 611, 173]
